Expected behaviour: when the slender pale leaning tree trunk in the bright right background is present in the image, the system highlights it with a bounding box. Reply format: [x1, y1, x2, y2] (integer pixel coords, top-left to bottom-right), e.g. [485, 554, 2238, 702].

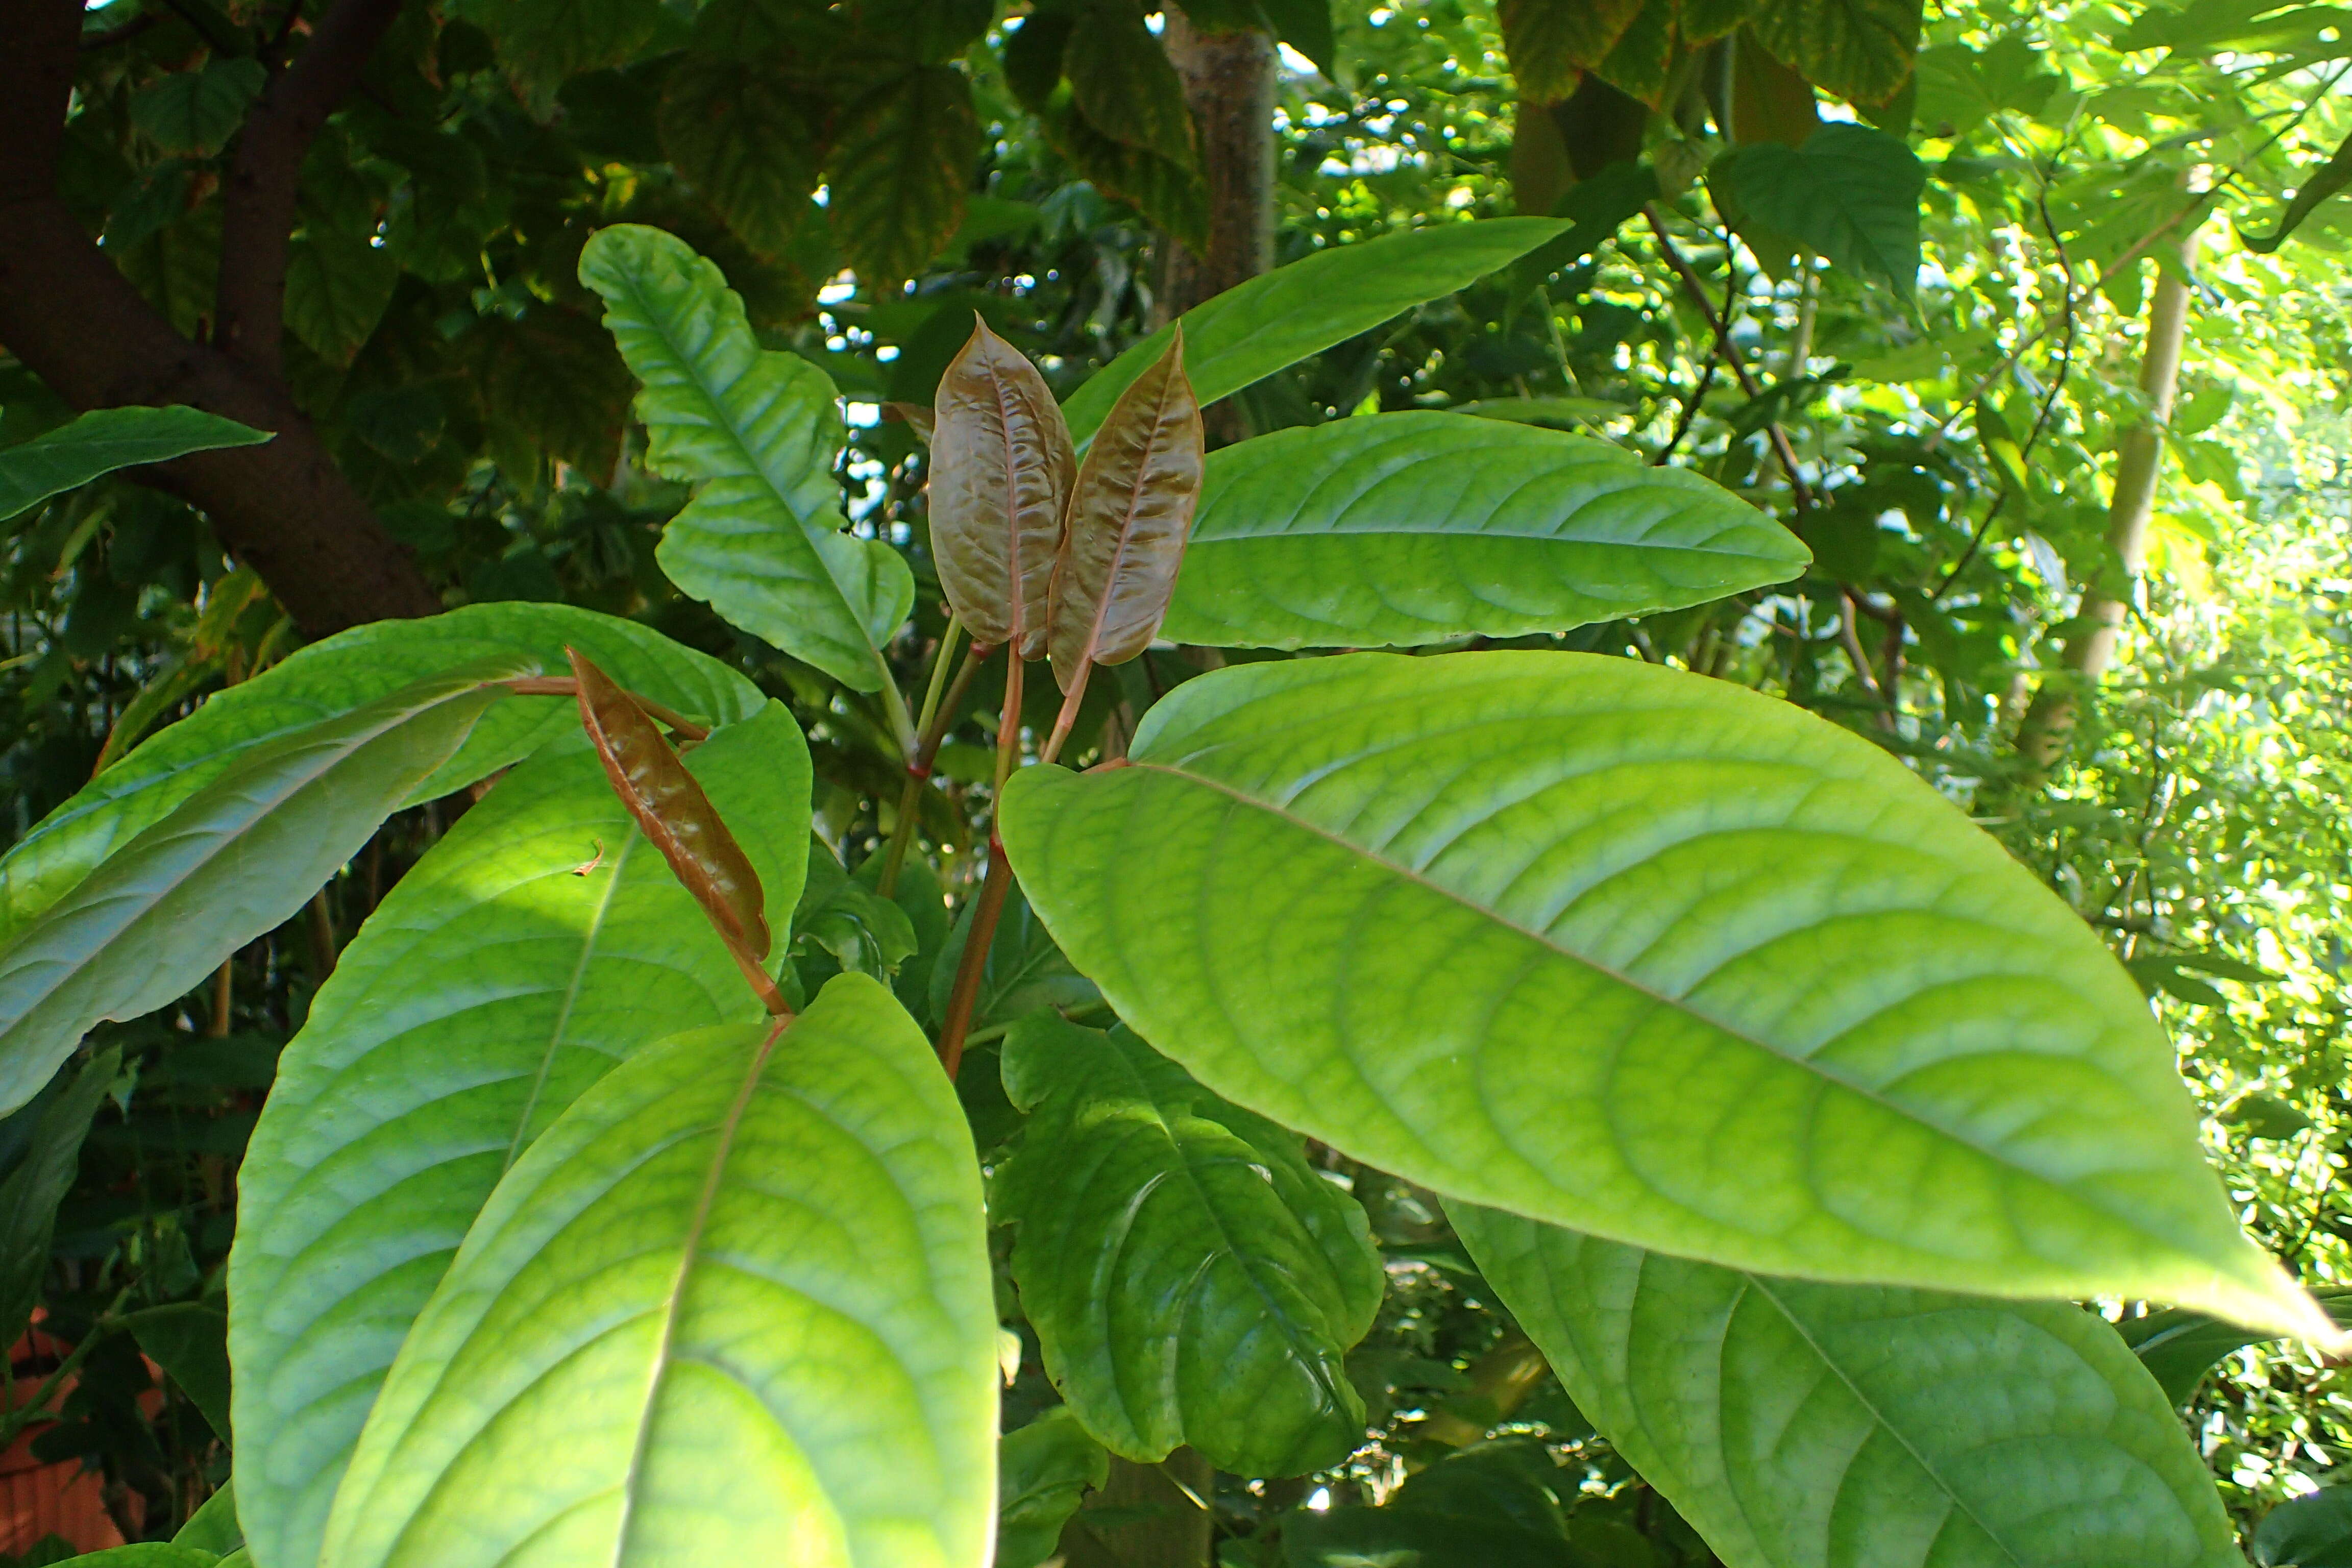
[2018, 235, 2190, 790]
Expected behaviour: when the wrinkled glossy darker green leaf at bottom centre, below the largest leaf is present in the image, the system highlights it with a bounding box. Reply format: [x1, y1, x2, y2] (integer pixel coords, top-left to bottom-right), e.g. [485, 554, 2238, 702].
[990, 1016, 1383, 1476]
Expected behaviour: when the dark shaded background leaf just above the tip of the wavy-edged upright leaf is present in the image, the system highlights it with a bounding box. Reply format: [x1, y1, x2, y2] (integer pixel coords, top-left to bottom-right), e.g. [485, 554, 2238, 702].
[656, 52, 821, 252]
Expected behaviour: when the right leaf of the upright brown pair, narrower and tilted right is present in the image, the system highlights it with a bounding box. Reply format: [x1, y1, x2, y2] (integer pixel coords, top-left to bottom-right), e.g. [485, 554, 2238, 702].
[1049, 327, 1202, 691]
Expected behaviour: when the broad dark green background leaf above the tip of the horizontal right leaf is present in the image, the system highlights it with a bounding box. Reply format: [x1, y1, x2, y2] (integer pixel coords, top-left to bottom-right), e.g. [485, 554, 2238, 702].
[1707, 125, 1926, 299]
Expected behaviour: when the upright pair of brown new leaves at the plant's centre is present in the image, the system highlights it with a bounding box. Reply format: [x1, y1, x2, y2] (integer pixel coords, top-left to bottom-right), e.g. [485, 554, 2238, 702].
[932, 320, 1204, 757]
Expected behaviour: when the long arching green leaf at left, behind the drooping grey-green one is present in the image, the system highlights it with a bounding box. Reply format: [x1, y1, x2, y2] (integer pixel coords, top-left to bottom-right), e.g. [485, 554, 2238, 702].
[0, 604, 767, 940]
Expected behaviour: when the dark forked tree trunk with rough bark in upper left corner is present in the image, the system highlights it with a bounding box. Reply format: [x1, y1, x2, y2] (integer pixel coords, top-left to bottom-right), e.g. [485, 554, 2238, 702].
[0, 0, 440, 637]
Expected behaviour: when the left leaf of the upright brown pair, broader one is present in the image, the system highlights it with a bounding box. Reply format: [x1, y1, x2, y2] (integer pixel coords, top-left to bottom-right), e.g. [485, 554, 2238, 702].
[932, 320, 1077, 658]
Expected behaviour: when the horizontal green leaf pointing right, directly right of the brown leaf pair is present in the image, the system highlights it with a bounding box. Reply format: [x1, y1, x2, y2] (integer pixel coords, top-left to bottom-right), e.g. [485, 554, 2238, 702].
[1162, 414, 1811, 649]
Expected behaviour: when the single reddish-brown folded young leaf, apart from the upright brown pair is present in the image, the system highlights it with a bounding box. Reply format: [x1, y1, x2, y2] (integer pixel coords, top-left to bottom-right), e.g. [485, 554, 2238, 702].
[565, 649, 778, 1009]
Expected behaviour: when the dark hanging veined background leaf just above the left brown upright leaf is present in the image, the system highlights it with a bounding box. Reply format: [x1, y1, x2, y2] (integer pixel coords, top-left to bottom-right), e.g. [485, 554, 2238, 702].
[825, 66, 981, 294]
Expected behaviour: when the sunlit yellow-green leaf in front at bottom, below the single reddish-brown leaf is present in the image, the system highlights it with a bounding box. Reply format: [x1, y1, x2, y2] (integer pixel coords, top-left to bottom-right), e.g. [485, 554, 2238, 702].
[322, 975, 997, 1568]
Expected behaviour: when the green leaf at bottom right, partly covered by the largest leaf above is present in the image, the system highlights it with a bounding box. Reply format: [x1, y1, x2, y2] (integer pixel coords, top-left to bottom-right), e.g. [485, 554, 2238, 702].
[1447, 1202, 2239, 1568]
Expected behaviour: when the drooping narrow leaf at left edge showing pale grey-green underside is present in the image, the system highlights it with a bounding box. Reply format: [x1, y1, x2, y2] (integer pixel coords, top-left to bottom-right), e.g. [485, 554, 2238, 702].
[0, 656, 522, 1110]
